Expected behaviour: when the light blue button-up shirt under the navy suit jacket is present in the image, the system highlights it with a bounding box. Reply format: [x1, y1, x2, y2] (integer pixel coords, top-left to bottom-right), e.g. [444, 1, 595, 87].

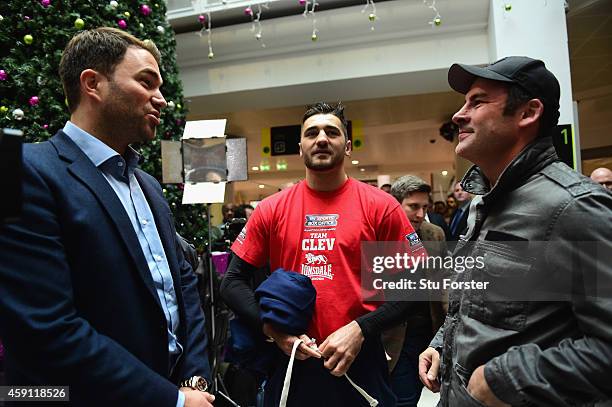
[63, 121, 185, 407]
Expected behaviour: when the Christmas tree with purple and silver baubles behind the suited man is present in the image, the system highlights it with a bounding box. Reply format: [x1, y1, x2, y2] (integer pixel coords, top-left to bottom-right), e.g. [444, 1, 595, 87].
[0, 0, 208, 250]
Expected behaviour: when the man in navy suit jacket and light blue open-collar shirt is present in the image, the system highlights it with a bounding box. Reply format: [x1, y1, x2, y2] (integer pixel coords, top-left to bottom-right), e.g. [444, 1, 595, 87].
[0, 28, 214, 407]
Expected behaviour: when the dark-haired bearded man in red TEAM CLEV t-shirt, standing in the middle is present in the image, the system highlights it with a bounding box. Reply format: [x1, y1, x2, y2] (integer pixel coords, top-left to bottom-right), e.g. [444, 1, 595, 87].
[221, 103, 424, 406]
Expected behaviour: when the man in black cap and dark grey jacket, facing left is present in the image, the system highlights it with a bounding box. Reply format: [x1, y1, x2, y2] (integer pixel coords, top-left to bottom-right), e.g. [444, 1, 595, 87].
[419, 57, 612, 407]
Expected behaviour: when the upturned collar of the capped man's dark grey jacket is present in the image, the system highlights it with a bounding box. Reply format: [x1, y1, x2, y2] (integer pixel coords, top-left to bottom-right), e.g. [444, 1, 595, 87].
[461, 136, 559, 201]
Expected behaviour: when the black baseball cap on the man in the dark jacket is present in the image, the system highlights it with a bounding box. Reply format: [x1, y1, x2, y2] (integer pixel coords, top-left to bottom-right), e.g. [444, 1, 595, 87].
[448, 56, 561, 127]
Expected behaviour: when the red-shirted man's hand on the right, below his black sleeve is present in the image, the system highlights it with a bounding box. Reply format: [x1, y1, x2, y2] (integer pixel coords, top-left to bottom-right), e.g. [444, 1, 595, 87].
[319, 321, 364, 377]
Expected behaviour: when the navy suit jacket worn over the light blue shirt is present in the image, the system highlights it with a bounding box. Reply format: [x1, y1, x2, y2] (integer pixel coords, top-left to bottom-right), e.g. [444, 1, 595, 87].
[0, 131, 210, 406]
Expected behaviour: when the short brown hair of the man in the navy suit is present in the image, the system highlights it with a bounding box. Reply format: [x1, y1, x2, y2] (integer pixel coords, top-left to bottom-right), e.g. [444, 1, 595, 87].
[59, 27, 161, 112]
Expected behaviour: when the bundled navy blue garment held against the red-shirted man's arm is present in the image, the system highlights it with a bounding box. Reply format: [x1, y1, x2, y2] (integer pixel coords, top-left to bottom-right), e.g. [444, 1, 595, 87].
[255, 269, 317, 335]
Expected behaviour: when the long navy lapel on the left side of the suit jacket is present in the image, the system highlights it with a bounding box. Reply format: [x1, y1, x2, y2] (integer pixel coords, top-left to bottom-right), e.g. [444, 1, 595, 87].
[51, 131, 161, 308]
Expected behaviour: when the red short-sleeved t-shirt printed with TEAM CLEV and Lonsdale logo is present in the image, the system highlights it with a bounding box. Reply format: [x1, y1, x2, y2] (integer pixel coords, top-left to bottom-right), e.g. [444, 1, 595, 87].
[232, 178, 424, 343]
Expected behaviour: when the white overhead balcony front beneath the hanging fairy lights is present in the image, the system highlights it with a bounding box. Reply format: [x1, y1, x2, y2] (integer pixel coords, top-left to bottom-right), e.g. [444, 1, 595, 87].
[177, 0, 488, 115]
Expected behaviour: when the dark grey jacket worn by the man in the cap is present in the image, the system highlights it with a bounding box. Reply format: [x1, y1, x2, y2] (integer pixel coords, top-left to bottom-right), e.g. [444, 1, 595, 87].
[431, 137, 612, 407]
